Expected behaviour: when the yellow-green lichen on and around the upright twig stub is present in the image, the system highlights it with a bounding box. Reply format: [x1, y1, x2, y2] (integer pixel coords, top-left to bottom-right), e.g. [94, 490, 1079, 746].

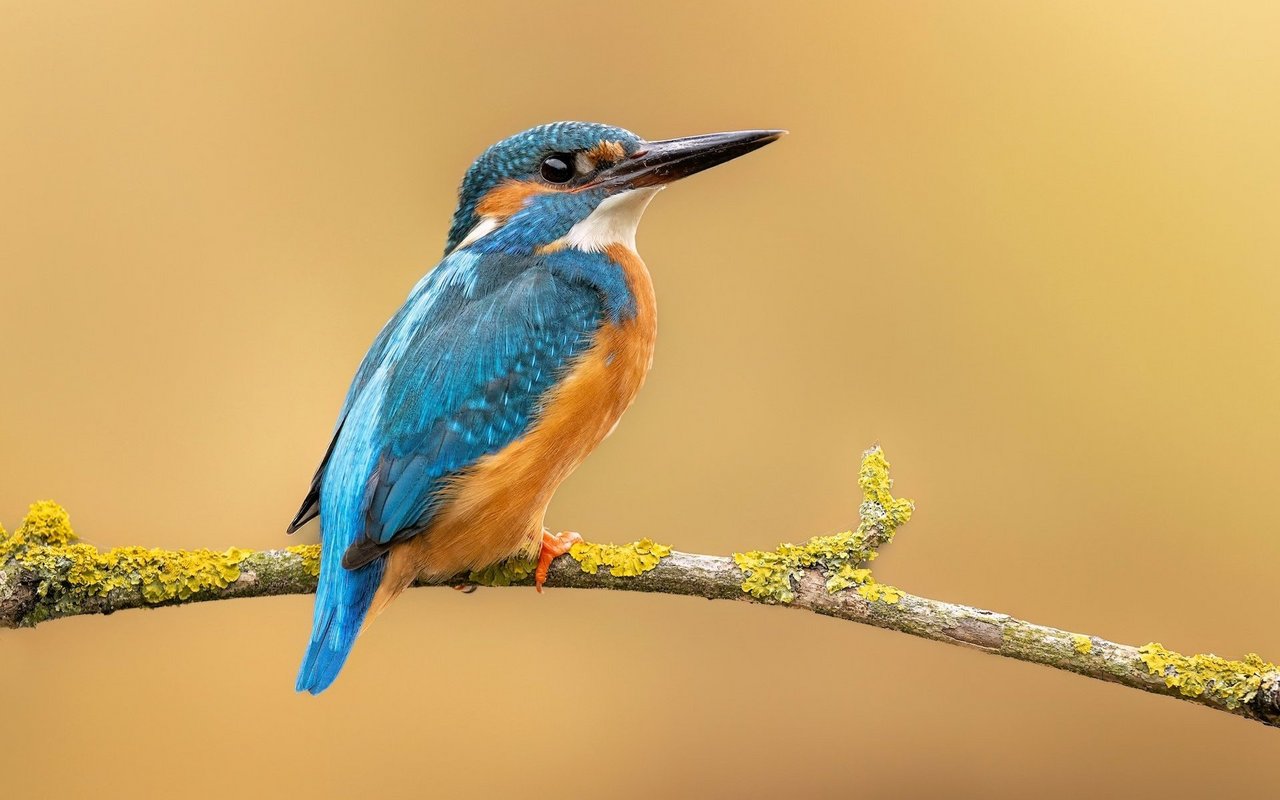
[733, 447, 915, 603]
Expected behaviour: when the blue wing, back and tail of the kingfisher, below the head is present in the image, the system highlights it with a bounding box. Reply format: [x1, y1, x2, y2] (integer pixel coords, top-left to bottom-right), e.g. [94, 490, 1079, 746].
[294, 251, 614, 692]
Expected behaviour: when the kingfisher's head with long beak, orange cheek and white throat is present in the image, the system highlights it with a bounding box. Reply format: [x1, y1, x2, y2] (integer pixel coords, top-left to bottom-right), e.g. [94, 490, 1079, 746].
[445, 122, 783, 253]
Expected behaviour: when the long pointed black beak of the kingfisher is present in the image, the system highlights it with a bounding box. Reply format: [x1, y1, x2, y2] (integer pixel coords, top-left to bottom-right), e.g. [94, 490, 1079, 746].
[591, 131, 786, 189]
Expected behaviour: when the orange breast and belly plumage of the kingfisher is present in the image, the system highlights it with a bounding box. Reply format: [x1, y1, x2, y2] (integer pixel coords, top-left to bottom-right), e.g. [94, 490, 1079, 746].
[370, 244, 657, 609]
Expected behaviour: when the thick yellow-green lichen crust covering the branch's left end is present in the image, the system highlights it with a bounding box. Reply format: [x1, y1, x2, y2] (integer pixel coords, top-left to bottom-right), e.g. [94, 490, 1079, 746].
[0, 500, 251, 625]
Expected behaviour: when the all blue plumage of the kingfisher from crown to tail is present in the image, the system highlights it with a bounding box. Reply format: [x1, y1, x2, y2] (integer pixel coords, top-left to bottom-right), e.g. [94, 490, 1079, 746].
[289, 123, 640, 694]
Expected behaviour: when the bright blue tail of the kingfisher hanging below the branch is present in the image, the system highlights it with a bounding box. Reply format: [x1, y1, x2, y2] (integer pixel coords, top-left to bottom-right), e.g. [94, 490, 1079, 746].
[296, 553, 387, 695]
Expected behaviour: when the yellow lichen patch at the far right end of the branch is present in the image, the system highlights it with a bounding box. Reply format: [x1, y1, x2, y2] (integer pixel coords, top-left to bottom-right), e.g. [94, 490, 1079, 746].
[1138, 643, 1280, 708]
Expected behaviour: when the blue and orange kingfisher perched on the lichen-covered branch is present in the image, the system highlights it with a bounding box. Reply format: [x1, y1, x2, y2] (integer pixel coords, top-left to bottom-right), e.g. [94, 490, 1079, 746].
[288, 122, 783, 694]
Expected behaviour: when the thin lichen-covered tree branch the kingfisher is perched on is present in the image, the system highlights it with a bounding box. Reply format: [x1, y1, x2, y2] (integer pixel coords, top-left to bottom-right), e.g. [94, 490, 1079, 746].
[0, 448, 1280, 727]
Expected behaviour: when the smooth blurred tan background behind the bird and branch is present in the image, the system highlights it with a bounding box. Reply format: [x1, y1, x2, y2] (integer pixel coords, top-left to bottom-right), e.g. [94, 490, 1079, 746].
[0, 0, 1280, 797]
